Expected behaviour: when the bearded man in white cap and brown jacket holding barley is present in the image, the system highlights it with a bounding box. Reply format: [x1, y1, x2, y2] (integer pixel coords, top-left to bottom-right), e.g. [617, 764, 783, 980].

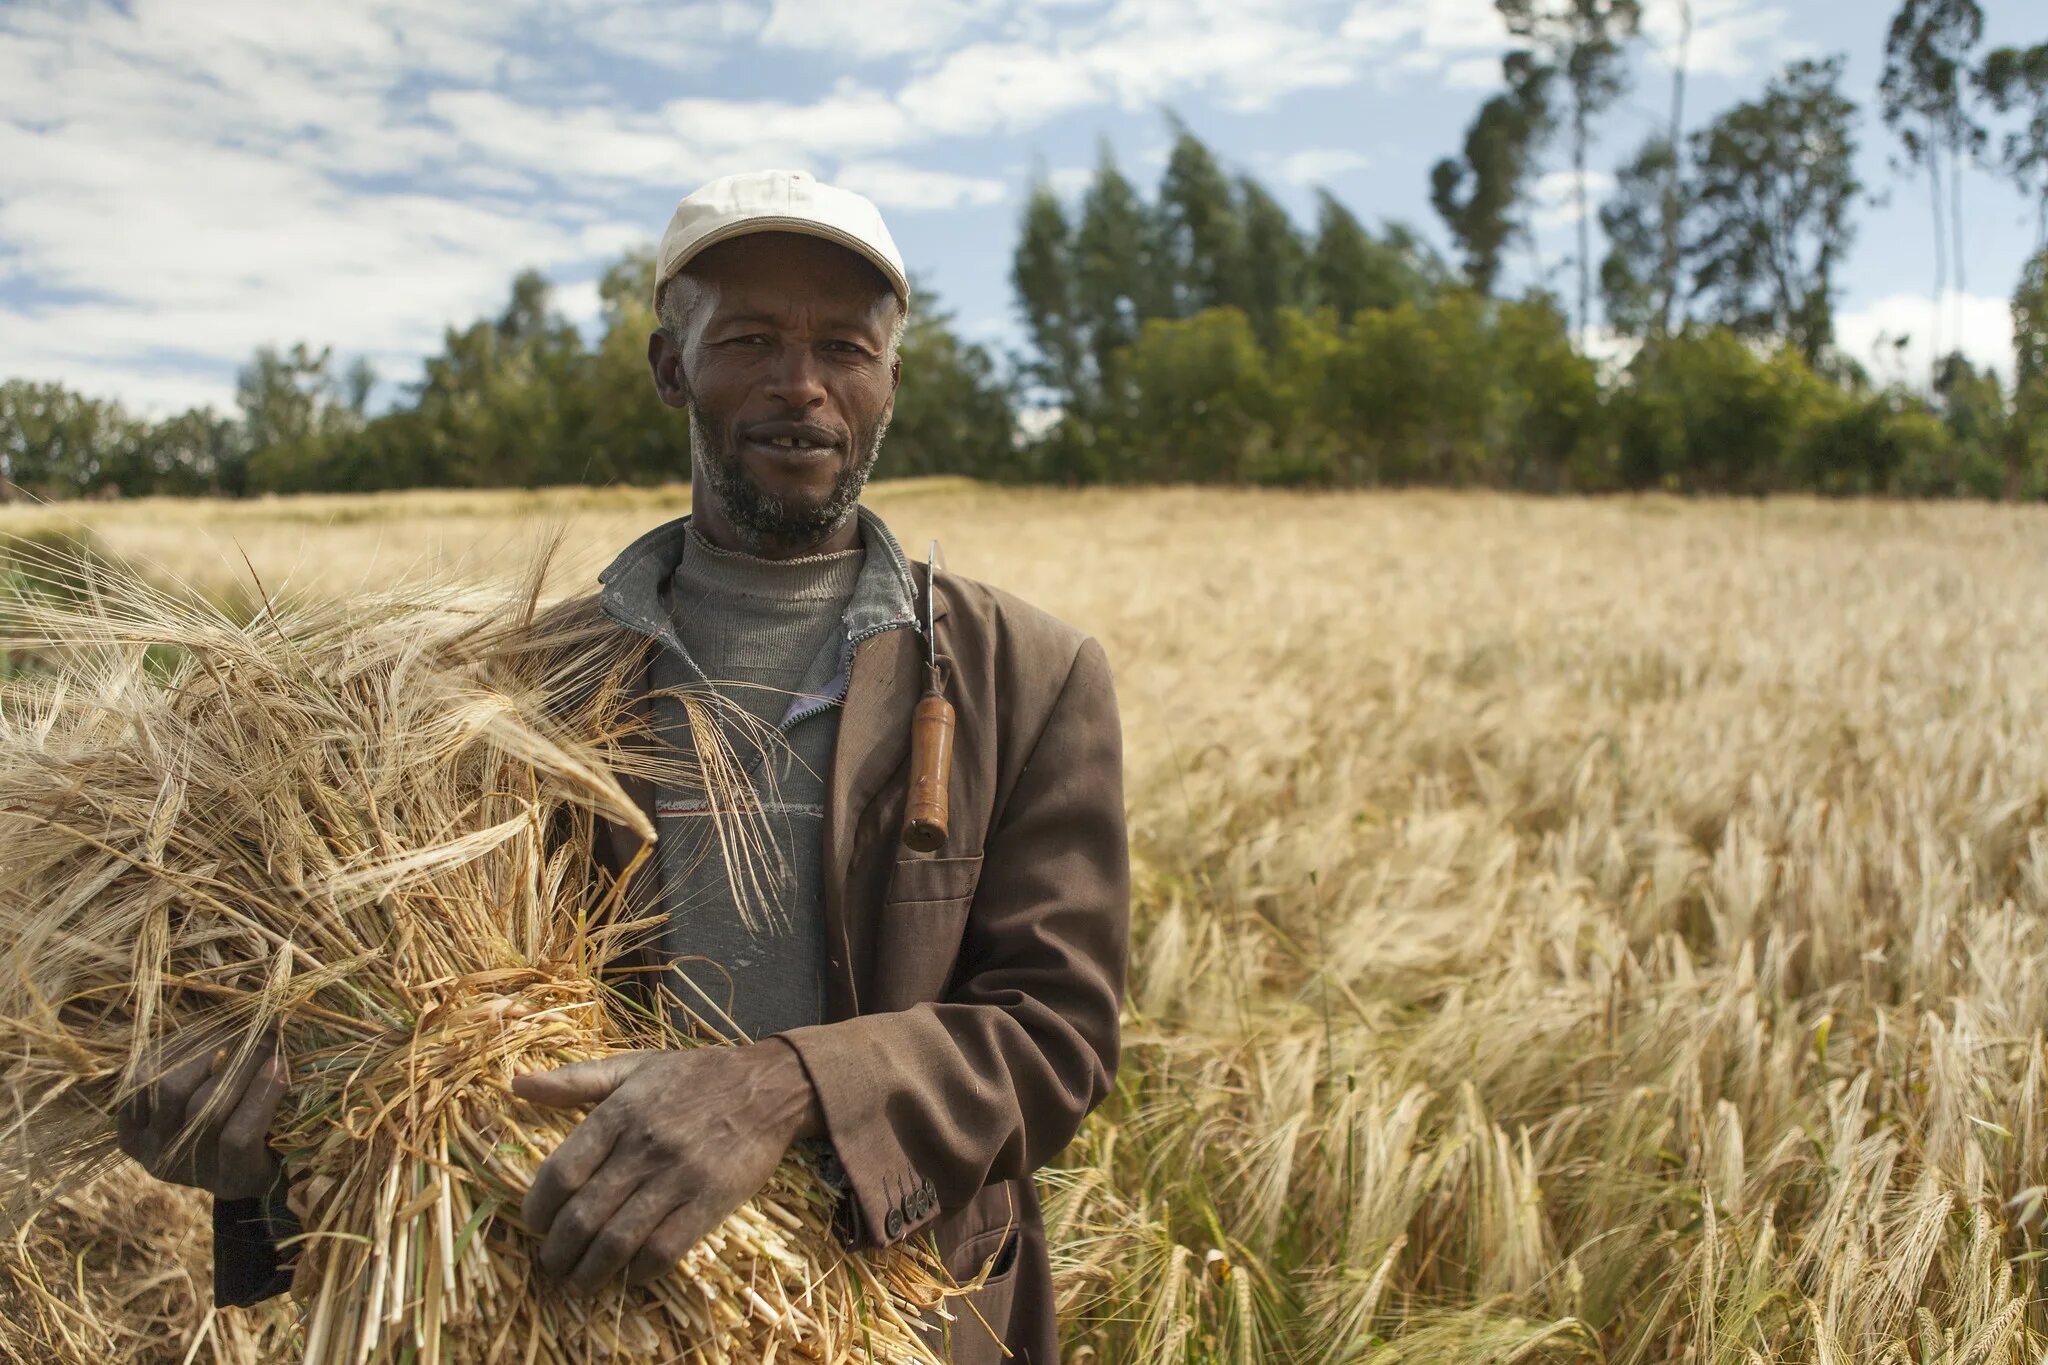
[121, 172, 1128, 1365]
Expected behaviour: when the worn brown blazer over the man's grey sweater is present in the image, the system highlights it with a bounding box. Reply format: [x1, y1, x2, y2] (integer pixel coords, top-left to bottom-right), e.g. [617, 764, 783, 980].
[606, 540, 1130, 1365]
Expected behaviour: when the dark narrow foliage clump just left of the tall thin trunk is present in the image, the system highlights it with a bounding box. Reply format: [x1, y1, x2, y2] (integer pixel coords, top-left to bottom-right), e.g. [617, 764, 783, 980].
[1430, 53, 1554, 295]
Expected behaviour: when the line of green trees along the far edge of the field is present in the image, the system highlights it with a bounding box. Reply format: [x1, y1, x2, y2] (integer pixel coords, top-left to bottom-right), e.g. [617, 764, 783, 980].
[0, 0, 2048, 497]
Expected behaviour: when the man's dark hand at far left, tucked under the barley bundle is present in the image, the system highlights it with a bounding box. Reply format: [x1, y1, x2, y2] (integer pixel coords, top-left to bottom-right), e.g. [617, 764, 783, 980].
[115, 1046, 287, 1199]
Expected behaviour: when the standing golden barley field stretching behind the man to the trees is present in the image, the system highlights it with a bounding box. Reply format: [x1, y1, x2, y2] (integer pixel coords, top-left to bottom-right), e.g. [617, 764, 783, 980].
[12, 481, 2048, 1365]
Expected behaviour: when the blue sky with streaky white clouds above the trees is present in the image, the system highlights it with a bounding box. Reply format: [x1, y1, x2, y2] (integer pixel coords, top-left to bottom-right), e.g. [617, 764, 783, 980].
[0, 0, 2048, 413]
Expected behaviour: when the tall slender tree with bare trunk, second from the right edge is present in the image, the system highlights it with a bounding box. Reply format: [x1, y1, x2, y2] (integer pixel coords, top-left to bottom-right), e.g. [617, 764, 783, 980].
[1878, 0, 1985, 360]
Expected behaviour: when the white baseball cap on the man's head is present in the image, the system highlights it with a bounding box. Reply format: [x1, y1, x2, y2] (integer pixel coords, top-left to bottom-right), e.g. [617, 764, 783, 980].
[653, 170, 909, 307]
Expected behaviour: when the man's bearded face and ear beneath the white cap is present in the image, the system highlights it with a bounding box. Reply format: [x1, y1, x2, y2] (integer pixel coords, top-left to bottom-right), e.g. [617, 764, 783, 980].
[647, 233, 897, 555]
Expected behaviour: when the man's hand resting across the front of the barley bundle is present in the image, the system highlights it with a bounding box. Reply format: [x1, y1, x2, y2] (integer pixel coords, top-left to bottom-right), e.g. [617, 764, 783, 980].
[512, 1038, 821, 1293]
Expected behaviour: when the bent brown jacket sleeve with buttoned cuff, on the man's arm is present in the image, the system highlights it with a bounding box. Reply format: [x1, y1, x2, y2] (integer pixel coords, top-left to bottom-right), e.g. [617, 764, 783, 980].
[780, 639, 1130, 1246]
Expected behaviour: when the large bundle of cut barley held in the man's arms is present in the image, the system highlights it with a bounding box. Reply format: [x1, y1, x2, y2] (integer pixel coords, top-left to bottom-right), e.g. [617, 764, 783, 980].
[0, 548, 942, 1363]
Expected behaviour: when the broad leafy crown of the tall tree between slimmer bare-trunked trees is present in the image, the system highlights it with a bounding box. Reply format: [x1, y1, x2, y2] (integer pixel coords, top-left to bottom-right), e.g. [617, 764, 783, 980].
[1692, 57, 1864, 364]
